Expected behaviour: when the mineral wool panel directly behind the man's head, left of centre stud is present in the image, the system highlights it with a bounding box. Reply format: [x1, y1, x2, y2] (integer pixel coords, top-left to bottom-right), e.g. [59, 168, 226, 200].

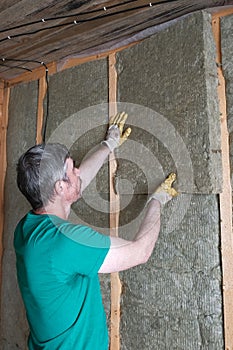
[47, 59, 109, 223]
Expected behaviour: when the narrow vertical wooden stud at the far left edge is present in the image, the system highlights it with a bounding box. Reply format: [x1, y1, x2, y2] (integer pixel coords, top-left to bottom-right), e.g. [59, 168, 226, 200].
[0, 81, 10, 287]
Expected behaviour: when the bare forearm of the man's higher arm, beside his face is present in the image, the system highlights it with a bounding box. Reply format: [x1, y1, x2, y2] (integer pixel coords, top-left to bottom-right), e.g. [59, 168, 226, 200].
[79, 145, 110, 191]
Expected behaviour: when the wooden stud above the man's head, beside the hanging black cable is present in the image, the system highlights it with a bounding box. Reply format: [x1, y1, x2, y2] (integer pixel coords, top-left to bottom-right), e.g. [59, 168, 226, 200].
[36, 76, 47, 144]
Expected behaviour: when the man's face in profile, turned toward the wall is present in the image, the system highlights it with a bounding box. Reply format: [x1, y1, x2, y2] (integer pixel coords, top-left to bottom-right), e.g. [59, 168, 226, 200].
[62, 158, 81, 204]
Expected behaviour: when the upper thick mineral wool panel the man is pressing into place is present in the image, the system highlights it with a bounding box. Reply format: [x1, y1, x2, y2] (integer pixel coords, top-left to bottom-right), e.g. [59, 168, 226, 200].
[116, 12, 222, 193]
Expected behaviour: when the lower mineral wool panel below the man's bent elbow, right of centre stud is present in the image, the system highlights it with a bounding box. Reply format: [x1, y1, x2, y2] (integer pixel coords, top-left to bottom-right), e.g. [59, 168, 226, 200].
[120, 194, 224, 350]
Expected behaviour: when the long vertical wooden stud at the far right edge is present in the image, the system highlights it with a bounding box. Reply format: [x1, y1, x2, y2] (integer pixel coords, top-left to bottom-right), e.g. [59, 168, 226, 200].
[212, 17, 233, 350]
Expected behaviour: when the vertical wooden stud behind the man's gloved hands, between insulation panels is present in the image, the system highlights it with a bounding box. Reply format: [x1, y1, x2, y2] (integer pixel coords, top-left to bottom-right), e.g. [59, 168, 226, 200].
[109, 54, 121, 350]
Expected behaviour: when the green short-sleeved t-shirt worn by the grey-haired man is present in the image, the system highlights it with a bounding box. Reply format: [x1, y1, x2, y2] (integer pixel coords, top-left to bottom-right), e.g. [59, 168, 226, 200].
[14, 212, 110, 350]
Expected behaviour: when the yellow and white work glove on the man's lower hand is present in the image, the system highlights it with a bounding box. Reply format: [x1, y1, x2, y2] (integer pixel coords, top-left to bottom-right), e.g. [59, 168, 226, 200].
[148, 173, 178, 205]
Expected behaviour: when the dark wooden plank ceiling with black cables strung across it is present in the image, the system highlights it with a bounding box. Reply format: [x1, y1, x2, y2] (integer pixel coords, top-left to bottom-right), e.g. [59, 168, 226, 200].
[0, 0, 233, 80]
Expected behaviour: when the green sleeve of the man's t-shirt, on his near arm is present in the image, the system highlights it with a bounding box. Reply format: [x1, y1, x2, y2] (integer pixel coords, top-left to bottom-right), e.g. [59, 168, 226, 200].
[53, 223, 110, 276]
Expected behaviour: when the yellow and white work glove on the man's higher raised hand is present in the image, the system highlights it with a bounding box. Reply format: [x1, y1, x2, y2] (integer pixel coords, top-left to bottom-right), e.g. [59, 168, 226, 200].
[102, 112, 131, 152]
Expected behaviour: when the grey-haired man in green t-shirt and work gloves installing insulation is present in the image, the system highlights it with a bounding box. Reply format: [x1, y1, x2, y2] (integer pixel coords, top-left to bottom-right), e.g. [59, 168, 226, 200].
[14, 112, 177, 350]
